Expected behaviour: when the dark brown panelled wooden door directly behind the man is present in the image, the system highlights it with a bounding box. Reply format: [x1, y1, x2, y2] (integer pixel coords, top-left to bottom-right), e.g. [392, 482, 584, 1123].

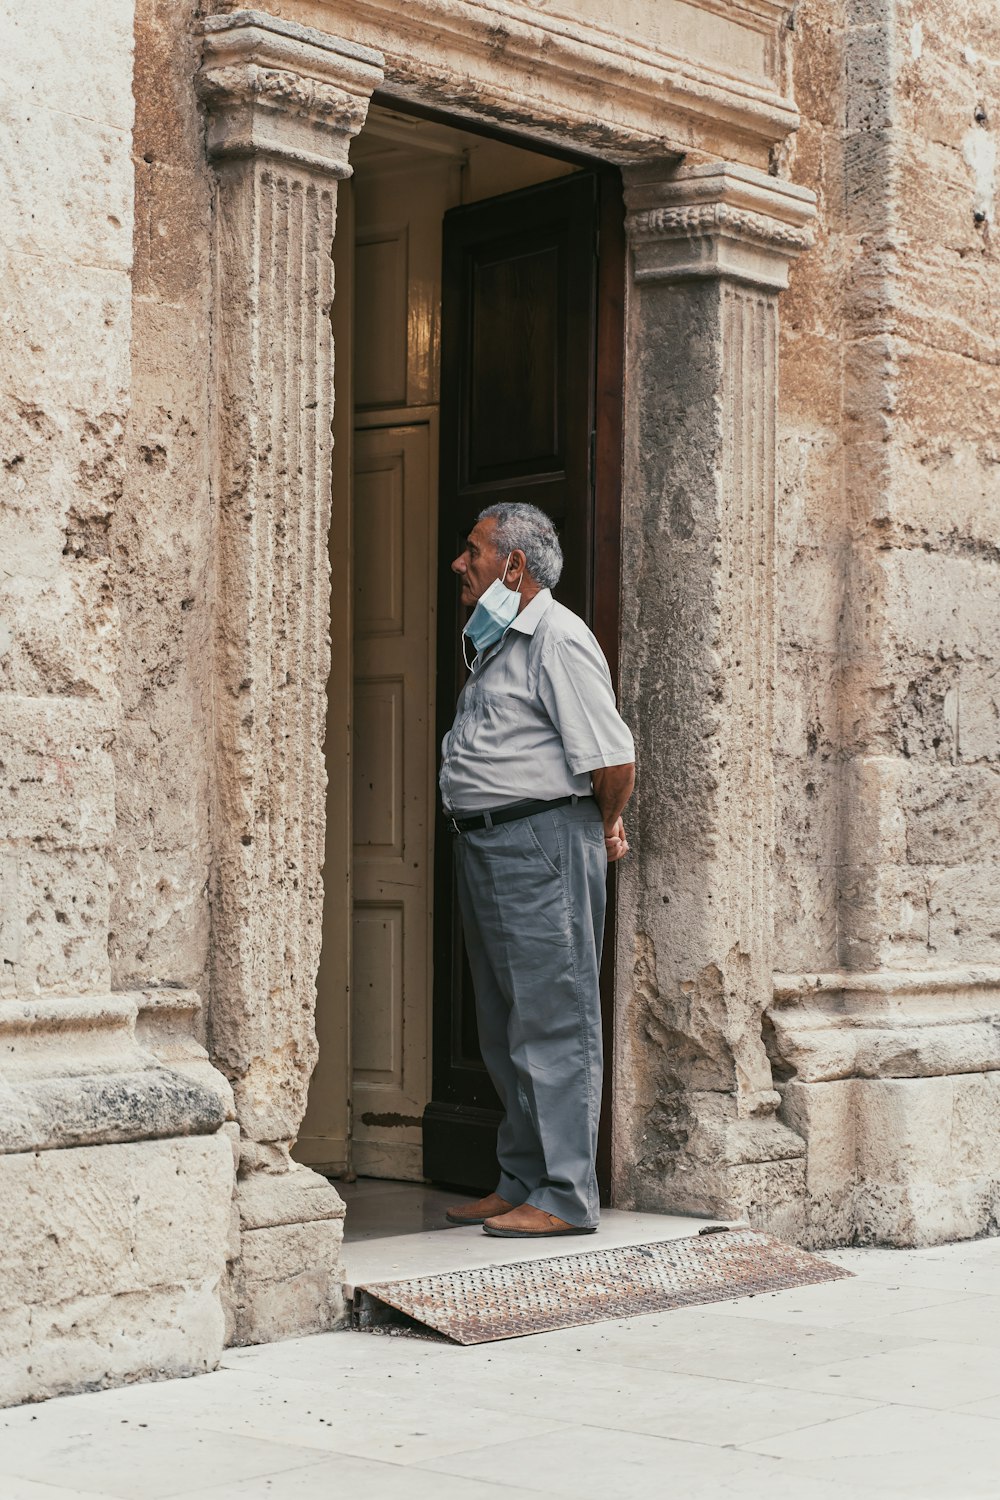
[423, 173, 605, 1188]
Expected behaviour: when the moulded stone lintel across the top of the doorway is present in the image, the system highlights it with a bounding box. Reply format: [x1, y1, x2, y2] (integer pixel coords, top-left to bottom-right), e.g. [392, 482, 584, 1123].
[313, 0, 799, 164]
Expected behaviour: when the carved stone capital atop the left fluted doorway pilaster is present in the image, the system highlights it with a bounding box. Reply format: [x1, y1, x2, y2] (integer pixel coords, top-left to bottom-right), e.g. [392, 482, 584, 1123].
[198, 11, 382, 177]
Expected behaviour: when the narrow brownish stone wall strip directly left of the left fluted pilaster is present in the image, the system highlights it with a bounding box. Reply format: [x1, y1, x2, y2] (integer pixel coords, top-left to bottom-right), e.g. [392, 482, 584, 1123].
[109, 0, 211, 996]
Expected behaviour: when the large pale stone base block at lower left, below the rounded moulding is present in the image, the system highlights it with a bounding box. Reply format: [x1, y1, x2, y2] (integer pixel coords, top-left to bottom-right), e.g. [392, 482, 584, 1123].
[0, 1134, 232, 1404]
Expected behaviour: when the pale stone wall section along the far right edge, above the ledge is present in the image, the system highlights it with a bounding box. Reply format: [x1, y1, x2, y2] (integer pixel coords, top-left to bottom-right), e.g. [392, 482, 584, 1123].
[841, 0, 1000, 969]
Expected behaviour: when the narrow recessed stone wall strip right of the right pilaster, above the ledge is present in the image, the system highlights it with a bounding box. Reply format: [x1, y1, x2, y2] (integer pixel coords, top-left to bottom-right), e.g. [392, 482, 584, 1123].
[775, 0, 847, 971]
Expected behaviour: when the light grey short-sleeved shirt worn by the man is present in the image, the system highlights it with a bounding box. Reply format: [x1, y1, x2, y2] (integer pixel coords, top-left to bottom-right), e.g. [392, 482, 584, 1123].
[439, 588, 636, 813]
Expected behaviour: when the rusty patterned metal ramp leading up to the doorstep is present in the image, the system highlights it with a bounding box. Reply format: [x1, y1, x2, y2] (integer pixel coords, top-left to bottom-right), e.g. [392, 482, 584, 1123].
[352, 1229, 850, 1344]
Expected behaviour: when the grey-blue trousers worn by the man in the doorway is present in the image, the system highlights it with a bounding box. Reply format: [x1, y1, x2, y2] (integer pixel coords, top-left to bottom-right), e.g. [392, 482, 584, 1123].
[454, 798, 607, 1229]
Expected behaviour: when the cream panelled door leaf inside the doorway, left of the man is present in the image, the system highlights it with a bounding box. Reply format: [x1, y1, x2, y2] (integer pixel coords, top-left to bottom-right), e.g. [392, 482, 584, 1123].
[351, 422, 436, 1178]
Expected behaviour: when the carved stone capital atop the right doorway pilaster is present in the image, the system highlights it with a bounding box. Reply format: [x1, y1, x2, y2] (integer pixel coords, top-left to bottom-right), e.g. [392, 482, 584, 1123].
[625, 162, 816, 291]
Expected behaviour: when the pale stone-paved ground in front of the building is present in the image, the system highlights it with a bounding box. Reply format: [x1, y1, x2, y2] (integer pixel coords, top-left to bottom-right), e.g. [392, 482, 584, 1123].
[0, 1230, 1000, 1500]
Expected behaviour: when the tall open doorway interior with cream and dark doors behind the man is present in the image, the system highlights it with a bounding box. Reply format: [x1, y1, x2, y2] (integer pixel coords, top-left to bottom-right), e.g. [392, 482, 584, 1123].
[294, 96, 625, 1218]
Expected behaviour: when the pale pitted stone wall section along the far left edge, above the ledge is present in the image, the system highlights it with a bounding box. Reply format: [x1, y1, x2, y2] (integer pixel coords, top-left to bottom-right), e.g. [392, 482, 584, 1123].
[0, 5, 132, 999]
